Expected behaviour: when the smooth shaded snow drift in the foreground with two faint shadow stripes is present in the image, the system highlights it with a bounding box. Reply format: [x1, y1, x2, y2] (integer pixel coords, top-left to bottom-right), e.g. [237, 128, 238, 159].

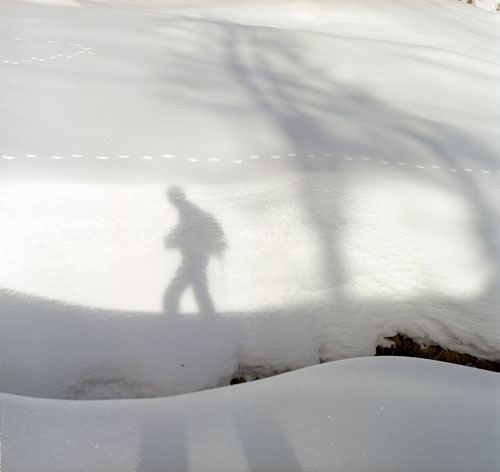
[1, 358, 500, 472]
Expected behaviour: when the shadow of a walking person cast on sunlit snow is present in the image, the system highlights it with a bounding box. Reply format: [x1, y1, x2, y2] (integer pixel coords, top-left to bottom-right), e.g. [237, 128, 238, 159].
[163, 186, 227, 315]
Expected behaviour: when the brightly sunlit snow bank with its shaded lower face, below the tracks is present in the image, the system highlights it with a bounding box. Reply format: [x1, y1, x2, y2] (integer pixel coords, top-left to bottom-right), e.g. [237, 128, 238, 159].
[0, 175, 500, 398]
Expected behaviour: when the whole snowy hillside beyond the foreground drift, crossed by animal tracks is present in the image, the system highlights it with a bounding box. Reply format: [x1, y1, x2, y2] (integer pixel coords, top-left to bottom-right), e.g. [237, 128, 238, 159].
[0, 0, 500, 398]
